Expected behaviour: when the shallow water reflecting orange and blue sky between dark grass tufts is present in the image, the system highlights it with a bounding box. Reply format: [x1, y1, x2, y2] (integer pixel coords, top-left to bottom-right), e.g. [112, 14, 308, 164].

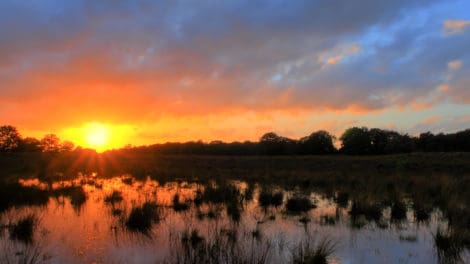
[0, 175, 470, 263]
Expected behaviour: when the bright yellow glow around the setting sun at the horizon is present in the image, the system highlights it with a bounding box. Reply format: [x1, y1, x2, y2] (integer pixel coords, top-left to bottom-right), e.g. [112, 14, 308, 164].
[59, 122, 134, 152]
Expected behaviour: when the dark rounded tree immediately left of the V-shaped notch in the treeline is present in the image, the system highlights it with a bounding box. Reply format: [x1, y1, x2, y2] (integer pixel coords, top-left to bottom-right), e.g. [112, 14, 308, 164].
[300, 130, 336, 155]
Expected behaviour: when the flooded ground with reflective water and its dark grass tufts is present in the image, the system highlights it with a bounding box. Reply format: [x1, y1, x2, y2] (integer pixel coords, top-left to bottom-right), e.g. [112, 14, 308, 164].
[0, 173, 470, 263]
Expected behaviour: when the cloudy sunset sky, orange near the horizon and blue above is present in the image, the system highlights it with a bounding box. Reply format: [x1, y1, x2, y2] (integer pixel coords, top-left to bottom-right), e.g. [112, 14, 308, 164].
[0, 0, 470, 147]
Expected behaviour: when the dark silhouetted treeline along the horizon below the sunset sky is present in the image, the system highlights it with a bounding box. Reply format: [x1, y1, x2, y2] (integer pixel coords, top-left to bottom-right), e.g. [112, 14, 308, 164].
[0, 125, 470, 155]
